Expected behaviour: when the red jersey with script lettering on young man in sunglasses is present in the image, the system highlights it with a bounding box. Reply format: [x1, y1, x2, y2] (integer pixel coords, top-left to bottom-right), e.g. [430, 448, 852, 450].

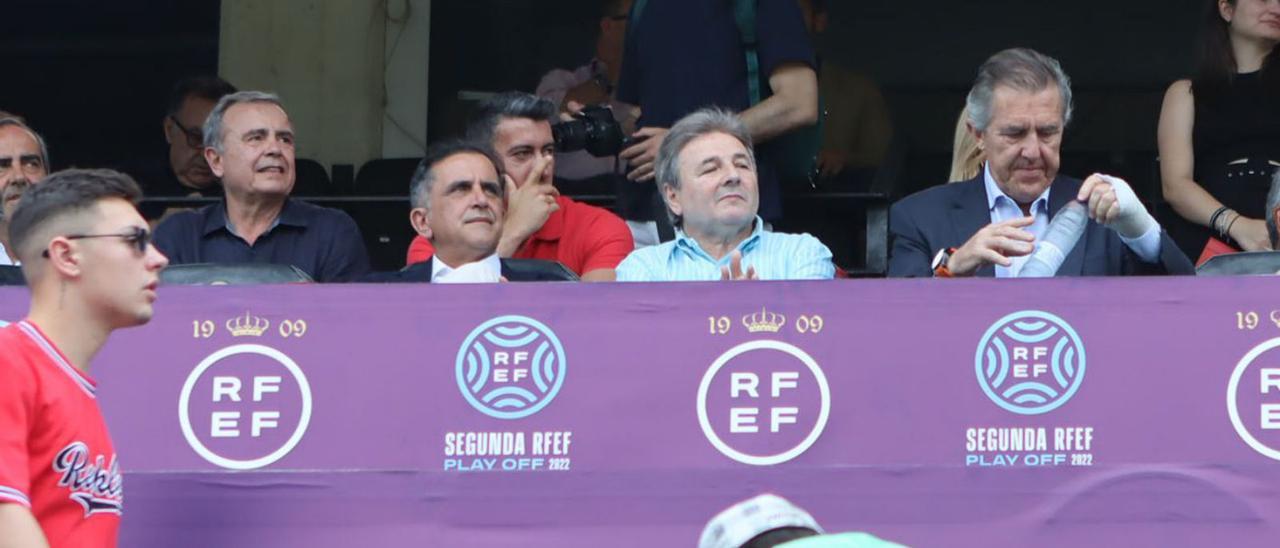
[0, 321, 124, 548]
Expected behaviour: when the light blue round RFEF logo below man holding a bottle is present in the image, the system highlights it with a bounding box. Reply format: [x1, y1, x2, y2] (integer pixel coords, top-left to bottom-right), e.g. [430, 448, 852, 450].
[974, 310, 1085, 415]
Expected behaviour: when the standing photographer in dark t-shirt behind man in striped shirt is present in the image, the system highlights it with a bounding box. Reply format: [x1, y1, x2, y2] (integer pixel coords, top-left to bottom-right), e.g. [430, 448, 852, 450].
[617, 0, 819, 242]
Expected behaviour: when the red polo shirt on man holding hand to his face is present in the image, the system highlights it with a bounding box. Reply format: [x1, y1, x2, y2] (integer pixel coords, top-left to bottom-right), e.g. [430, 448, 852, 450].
[406, 196, 635, 275]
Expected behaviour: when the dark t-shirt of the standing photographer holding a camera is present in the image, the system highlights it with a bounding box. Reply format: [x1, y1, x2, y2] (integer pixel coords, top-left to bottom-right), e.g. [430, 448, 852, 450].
[617, 0, 814, 220]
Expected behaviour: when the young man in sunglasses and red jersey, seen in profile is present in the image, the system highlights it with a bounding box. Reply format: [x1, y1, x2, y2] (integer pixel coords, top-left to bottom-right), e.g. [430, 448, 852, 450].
[0, 169, 169, 548]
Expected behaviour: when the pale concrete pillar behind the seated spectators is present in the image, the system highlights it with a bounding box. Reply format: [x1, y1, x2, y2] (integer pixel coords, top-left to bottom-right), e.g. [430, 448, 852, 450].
[219, 0, 430, 166]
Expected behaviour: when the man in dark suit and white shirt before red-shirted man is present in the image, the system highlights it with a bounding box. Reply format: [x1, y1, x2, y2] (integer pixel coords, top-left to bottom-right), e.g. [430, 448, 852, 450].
[365, 141, 572, 283]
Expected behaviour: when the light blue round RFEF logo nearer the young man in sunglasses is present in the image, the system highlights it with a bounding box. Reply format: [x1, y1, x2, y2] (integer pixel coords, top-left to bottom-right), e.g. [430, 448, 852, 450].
[457, 316, 567, 419]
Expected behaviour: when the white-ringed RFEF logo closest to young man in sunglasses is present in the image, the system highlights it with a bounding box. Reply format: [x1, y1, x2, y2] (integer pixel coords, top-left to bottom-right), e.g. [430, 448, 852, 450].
[178, 344, 311, 470]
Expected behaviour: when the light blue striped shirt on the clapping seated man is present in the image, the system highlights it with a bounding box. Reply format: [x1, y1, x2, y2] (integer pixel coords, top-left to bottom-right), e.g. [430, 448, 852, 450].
[617, 216, 836, 282]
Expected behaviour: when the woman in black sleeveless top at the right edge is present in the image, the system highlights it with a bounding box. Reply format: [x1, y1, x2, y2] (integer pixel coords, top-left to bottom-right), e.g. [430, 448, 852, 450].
[1158, 0, 1280, 257]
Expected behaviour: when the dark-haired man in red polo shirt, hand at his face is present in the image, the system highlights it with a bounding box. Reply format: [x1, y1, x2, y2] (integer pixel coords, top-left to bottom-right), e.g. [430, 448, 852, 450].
[408, 92, 635, 282]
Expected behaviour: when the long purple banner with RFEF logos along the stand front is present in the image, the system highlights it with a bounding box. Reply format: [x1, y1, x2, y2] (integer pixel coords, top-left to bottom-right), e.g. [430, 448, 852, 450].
[0, 278, 1280, 547]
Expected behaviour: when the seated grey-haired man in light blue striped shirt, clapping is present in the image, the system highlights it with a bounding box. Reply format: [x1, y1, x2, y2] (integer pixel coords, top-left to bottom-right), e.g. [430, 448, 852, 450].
[617, 109, 836, 282]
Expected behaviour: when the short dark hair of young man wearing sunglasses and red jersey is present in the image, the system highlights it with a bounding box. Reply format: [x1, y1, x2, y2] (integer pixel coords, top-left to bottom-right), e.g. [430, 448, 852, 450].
[9, 169, 142, 261]
